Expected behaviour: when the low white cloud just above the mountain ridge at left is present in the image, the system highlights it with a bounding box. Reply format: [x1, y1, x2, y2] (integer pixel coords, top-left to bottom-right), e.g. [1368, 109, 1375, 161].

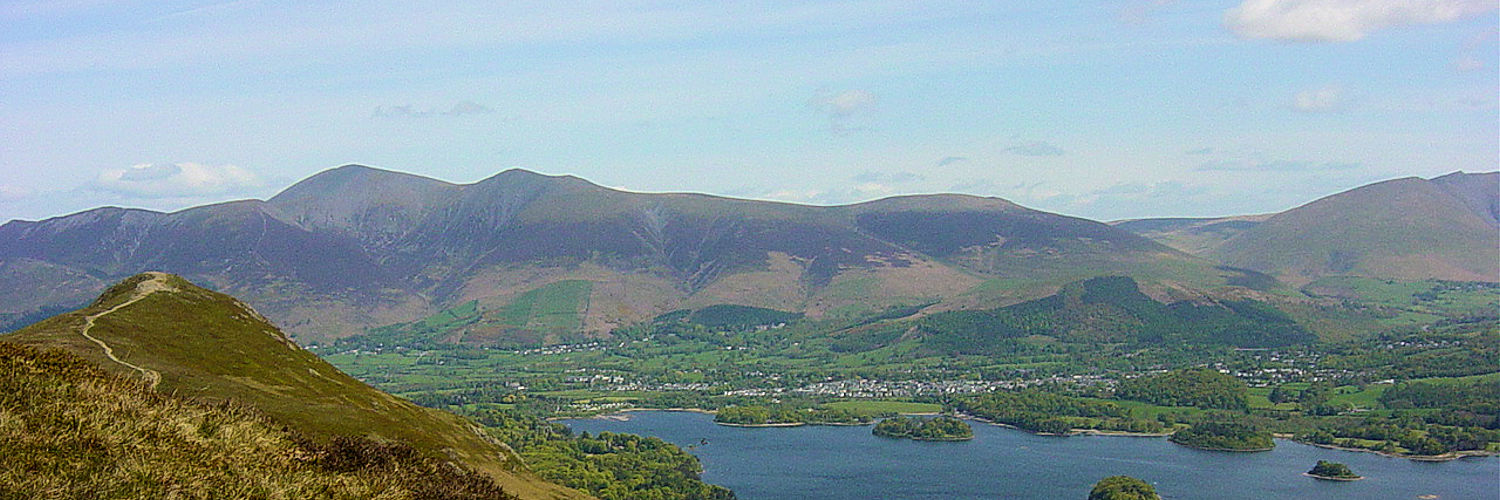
[92, 162, 266, 198]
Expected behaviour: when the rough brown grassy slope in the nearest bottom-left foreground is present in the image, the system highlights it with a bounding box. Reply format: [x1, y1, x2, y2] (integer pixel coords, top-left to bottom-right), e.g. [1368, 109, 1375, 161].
[0, 342, 516, 500]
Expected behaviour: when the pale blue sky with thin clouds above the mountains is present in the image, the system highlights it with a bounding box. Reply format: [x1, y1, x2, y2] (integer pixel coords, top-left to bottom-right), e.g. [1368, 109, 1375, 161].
[0, 0, 1500, 221]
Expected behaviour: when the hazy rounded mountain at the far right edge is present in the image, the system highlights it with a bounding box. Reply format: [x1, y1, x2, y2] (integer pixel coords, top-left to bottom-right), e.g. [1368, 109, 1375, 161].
[1206, 173, 1500, 284]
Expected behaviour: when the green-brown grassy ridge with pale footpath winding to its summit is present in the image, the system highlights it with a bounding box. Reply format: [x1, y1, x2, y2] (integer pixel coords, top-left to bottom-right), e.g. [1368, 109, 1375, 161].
[0, 273, 584, 498]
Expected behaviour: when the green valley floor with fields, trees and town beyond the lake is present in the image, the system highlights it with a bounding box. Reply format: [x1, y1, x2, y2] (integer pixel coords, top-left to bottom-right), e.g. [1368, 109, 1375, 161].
[314, 274, 1500, 456]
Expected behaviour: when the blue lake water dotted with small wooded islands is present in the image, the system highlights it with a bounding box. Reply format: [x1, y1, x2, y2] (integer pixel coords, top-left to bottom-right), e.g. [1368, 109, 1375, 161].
[564, 411, 1500, 500]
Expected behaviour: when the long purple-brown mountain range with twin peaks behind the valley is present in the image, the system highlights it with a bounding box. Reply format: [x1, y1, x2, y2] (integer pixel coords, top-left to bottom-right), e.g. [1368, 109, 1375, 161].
[0, 165, 1244, 342]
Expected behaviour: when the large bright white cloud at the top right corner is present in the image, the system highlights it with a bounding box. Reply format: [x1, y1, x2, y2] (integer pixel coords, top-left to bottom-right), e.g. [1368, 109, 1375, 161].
[1224, 0, 1497, 42]
